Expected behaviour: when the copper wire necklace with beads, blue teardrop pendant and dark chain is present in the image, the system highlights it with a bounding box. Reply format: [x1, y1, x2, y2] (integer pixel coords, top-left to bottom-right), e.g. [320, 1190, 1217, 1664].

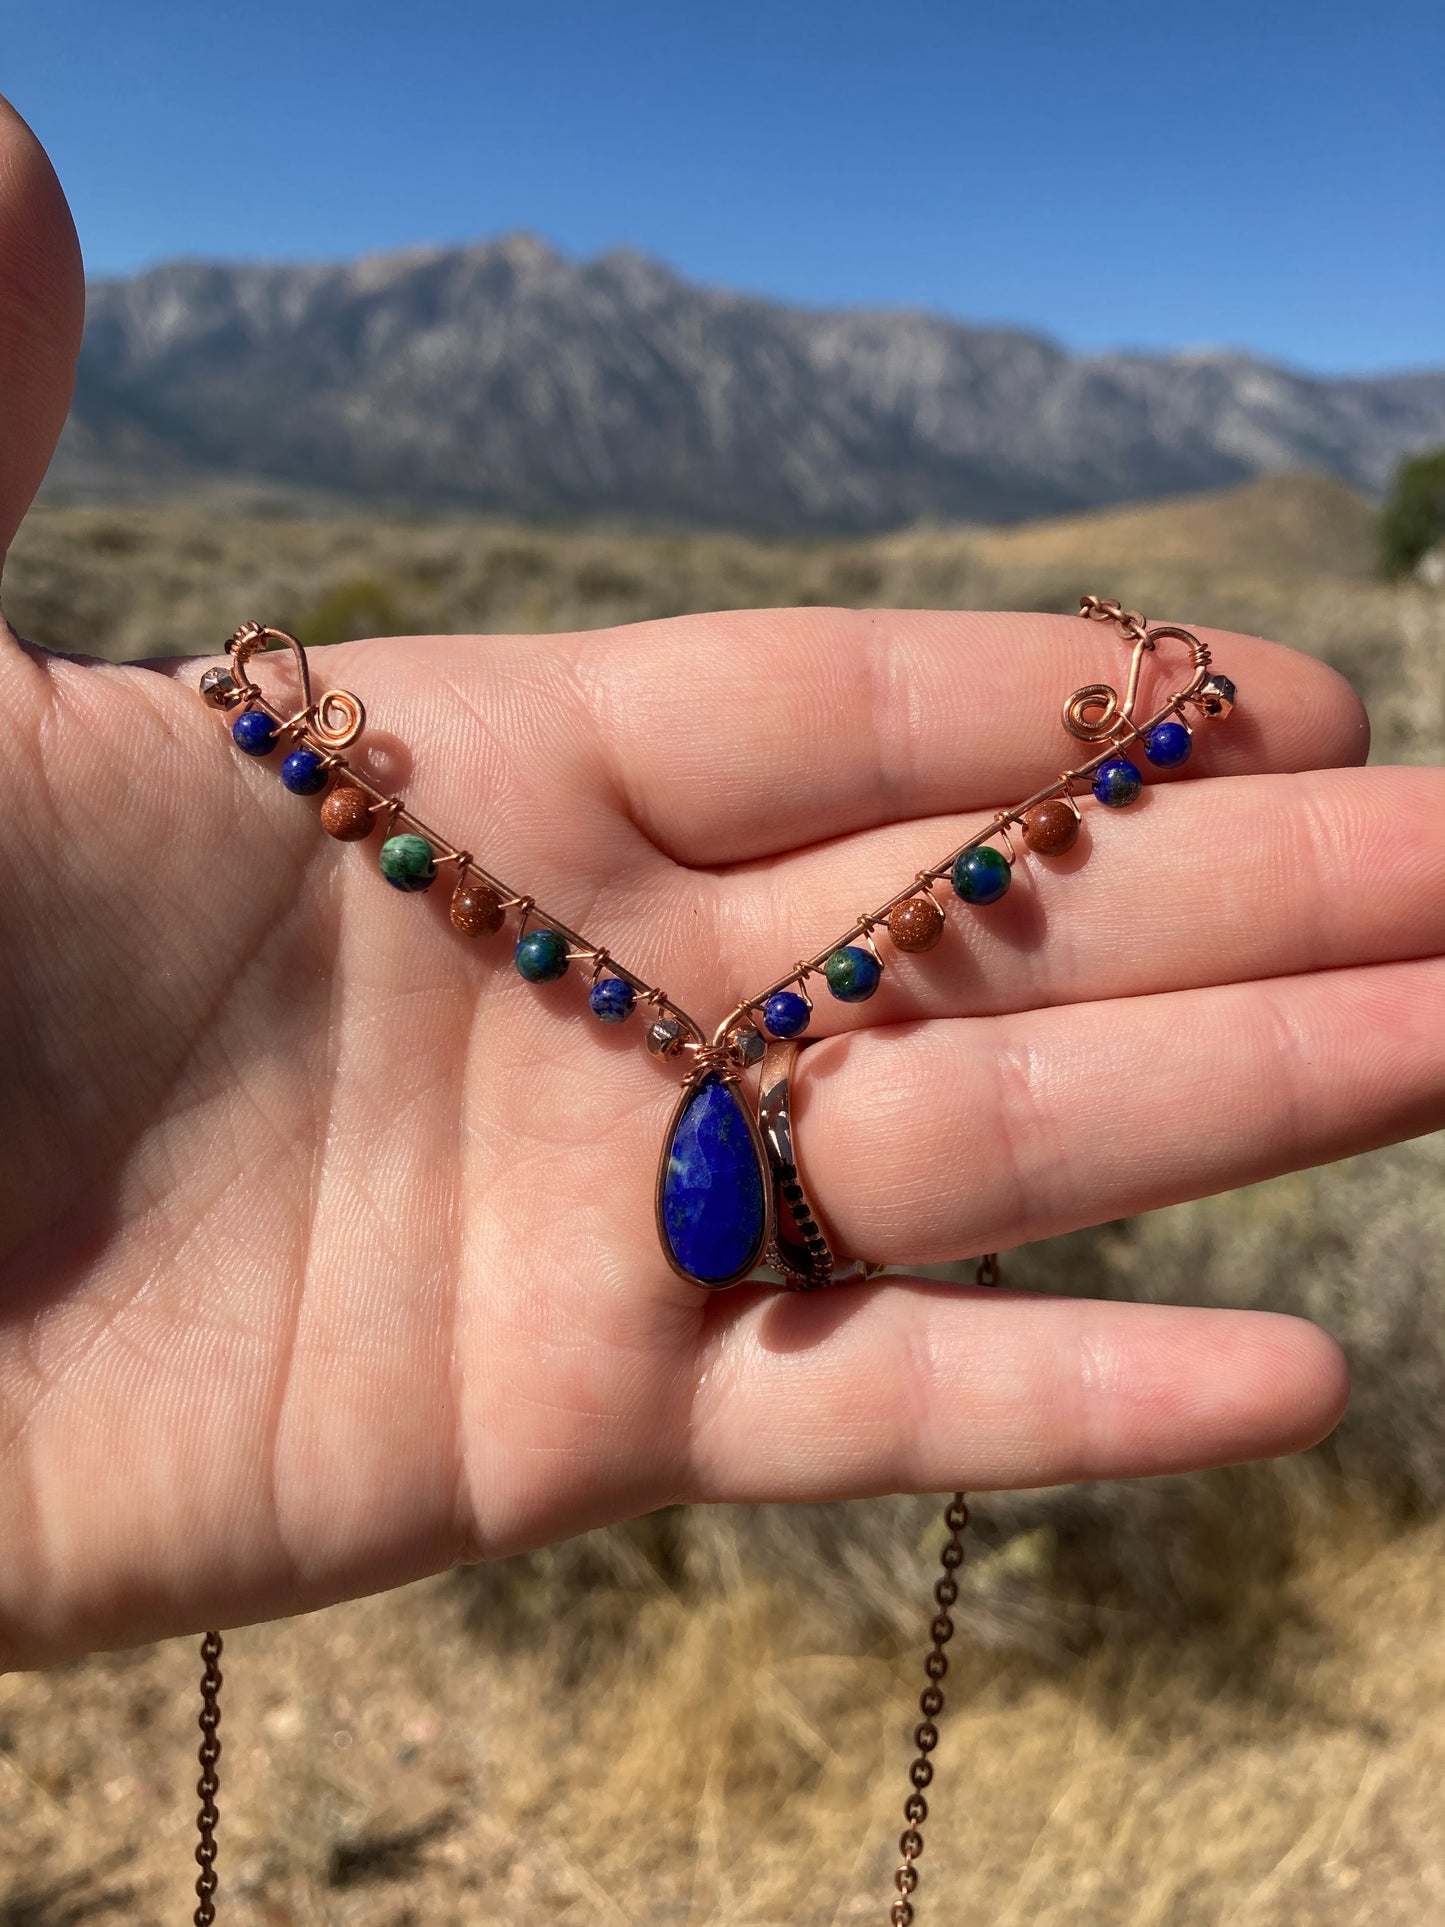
[193, 595, 1235, 1927]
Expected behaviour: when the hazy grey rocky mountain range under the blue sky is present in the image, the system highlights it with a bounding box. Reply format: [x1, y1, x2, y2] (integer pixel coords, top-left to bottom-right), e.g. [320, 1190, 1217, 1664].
[50, 237, 1445, 532]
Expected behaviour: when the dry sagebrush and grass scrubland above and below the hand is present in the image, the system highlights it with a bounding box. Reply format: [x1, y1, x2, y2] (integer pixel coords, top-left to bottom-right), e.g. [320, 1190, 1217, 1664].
[0, 478, 1445, 1927]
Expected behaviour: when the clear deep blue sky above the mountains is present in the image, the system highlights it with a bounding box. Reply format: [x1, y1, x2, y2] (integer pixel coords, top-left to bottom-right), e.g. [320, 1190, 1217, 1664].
[0, 0, 1445, 370]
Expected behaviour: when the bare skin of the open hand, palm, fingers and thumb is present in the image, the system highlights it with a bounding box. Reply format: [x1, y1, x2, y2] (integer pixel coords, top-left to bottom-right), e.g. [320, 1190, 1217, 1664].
[0, 101, 1445, 1665]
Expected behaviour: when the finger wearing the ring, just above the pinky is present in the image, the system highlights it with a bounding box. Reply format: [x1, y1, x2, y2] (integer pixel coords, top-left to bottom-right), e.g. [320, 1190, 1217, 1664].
[794, 958, 1445, 1264]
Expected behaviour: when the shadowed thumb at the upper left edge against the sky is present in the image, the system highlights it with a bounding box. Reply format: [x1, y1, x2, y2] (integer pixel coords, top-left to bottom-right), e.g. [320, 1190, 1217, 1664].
[0, 98, 85, 565]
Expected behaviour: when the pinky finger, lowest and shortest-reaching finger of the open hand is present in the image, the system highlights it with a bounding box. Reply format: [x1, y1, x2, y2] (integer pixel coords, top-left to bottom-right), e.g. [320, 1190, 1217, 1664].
[688, 1280, 1349, 1501]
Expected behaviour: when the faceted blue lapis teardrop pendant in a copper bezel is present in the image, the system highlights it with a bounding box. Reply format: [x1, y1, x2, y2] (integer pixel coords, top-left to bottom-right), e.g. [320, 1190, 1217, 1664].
[657, 1071, 773, 1289]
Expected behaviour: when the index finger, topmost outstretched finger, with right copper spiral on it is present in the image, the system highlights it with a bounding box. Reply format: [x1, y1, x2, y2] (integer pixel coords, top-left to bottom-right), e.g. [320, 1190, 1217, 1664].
[576, 609, 1370, 865]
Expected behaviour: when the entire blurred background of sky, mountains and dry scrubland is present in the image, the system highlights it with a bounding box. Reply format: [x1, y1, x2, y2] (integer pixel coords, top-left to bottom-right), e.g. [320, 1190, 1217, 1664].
[0, 0, 1445, 1927]
